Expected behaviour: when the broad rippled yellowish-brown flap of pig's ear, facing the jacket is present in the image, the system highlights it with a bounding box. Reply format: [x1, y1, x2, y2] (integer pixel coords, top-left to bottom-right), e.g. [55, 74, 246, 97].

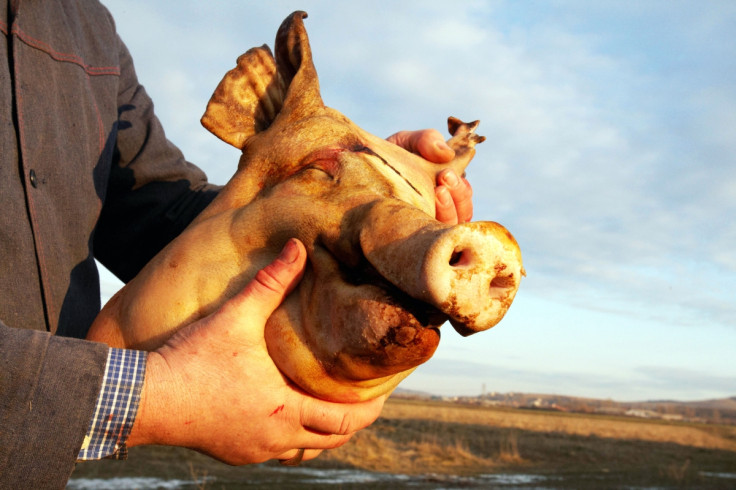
[201, 45, 286, 149]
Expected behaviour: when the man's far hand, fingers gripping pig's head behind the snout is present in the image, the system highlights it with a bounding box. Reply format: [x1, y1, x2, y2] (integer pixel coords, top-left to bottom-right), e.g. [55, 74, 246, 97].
[386, 129, 473, 225]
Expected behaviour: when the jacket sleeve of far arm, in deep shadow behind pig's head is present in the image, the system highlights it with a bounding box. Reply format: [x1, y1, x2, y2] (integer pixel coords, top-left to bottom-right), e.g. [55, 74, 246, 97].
[94, 34, 219, 282]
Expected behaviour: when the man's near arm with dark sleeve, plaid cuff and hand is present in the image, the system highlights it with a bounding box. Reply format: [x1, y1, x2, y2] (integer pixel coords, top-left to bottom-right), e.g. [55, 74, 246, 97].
[0, 240, 384, 488]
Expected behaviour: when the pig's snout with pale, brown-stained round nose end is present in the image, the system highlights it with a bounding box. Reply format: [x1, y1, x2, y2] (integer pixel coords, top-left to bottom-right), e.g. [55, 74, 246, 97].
[360, 203, 524, 335]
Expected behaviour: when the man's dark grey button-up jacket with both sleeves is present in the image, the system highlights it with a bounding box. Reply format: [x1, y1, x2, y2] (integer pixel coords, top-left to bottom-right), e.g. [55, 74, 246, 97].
[0, 0, 216, 488]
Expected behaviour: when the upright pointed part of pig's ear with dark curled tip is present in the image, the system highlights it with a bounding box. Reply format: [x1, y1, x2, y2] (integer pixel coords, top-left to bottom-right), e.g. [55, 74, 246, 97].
[275, 11, 324, 120]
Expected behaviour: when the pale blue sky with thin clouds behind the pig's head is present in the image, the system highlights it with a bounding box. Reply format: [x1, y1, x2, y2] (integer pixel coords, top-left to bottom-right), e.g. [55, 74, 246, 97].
[103, 0, 736, 401]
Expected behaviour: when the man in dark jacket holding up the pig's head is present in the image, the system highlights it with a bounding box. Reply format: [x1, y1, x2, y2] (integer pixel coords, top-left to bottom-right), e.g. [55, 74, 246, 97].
[0, 0, 472, 488]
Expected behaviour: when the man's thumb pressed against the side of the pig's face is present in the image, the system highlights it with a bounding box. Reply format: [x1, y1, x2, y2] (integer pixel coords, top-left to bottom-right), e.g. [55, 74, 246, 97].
[224, 238, 307, 325]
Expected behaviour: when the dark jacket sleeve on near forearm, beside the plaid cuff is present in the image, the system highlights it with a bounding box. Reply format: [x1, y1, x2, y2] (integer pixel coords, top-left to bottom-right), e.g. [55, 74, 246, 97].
[0, 322, 108, 488]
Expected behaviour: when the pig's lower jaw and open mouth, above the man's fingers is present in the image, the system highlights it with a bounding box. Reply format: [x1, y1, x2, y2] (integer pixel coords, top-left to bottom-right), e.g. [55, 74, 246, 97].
[266, 237, 447, 402]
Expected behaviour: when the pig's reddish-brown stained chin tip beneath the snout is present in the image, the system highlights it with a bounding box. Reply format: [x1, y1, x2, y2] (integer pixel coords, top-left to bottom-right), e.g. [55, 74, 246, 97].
[319, 283, 440, 381]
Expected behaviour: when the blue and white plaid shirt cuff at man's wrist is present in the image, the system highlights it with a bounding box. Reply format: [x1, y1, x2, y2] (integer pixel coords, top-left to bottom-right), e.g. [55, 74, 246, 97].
[77, 348, 147, 461]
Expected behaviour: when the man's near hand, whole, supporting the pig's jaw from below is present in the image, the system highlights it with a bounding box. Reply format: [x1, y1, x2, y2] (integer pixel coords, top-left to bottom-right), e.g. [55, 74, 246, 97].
[128, 240, 385, 465]
